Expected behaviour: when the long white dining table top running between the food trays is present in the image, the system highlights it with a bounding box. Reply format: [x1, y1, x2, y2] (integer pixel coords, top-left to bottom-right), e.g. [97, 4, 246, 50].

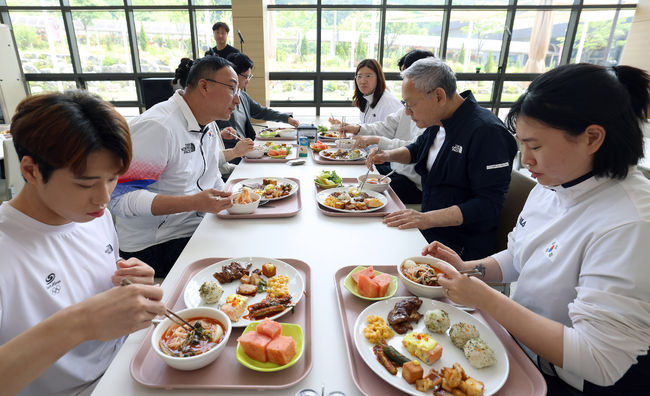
[93, 125, 426, 396]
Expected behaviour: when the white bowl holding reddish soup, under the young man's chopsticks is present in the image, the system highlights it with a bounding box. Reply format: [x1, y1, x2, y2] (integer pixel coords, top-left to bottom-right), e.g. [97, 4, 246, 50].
[151, 307, 232, 371]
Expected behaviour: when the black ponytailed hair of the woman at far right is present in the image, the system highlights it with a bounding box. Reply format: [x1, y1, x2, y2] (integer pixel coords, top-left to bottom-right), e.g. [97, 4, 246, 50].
[506, 63, 650, 179]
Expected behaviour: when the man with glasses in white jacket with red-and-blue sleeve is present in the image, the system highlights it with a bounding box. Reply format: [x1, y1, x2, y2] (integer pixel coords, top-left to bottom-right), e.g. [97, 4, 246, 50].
[110, 56, 253, 277]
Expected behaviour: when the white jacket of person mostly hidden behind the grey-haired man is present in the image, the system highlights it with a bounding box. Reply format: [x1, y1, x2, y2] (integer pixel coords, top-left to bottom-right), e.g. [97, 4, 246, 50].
[358, 104, 426, 190]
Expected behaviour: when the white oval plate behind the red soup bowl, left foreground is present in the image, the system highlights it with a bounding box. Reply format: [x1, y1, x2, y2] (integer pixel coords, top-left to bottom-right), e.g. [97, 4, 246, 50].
[183, 257, 305, 327]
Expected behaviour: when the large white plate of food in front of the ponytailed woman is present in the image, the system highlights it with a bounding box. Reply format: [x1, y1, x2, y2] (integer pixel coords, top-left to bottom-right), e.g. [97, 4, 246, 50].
[353, 297, 510, 396]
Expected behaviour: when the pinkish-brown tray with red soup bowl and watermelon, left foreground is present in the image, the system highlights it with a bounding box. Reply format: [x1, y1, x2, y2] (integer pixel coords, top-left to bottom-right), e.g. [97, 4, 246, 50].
[130, 258, 312, 390]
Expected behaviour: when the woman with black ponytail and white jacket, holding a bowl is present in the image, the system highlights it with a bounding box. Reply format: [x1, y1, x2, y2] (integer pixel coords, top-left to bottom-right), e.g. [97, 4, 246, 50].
[423, 64, 650, 395]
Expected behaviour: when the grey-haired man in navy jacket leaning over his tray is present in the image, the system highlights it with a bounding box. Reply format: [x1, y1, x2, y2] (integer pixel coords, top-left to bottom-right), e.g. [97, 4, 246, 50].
[368, 58, 517, 260]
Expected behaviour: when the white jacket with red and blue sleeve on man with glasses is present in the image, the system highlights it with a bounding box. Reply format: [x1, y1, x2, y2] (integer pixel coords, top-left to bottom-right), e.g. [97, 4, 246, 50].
[110, 90, 224, 252]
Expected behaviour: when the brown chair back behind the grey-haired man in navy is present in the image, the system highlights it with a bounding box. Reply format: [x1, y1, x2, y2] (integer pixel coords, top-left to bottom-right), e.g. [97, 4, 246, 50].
[490, 169, 536, 296]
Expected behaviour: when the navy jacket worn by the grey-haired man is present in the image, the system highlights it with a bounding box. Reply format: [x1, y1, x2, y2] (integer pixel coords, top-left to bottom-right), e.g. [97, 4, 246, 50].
[406, 91, 517, 260]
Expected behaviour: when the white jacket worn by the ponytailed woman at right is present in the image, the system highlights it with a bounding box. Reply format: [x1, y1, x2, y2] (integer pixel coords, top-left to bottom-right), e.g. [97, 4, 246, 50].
[493, 167, 650, 390]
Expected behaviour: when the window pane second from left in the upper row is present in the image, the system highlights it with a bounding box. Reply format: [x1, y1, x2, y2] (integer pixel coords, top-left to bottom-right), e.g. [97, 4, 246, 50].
[72, 11, 133, 73]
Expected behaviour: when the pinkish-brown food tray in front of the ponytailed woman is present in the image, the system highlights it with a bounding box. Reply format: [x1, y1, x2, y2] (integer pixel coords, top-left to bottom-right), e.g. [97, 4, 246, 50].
[334, 265, 546, 396]
